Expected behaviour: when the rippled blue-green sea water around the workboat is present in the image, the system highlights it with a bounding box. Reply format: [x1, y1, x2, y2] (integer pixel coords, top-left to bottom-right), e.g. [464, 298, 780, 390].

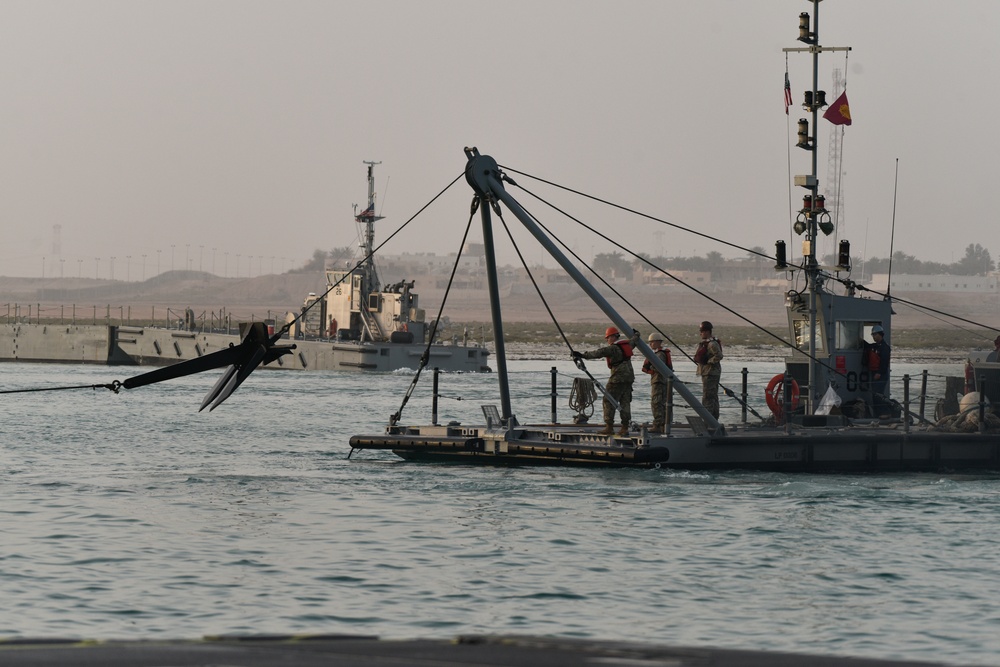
[0, 360, 1000, 664]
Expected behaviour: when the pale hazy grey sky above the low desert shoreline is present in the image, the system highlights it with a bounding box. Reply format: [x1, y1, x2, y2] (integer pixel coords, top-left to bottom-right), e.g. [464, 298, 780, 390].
[0, 0, 1000, 280]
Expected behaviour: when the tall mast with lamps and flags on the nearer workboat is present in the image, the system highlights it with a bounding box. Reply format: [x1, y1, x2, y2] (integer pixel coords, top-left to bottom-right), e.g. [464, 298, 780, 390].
[782, 0, 851, 414]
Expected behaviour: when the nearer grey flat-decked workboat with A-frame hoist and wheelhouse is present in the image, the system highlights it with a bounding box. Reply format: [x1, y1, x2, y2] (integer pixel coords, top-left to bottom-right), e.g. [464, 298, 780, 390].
[350, 0, 1000, 472]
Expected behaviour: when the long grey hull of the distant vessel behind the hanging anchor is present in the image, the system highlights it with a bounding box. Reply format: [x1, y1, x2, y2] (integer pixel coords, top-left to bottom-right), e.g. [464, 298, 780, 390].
[0, 324, 489, 373]
